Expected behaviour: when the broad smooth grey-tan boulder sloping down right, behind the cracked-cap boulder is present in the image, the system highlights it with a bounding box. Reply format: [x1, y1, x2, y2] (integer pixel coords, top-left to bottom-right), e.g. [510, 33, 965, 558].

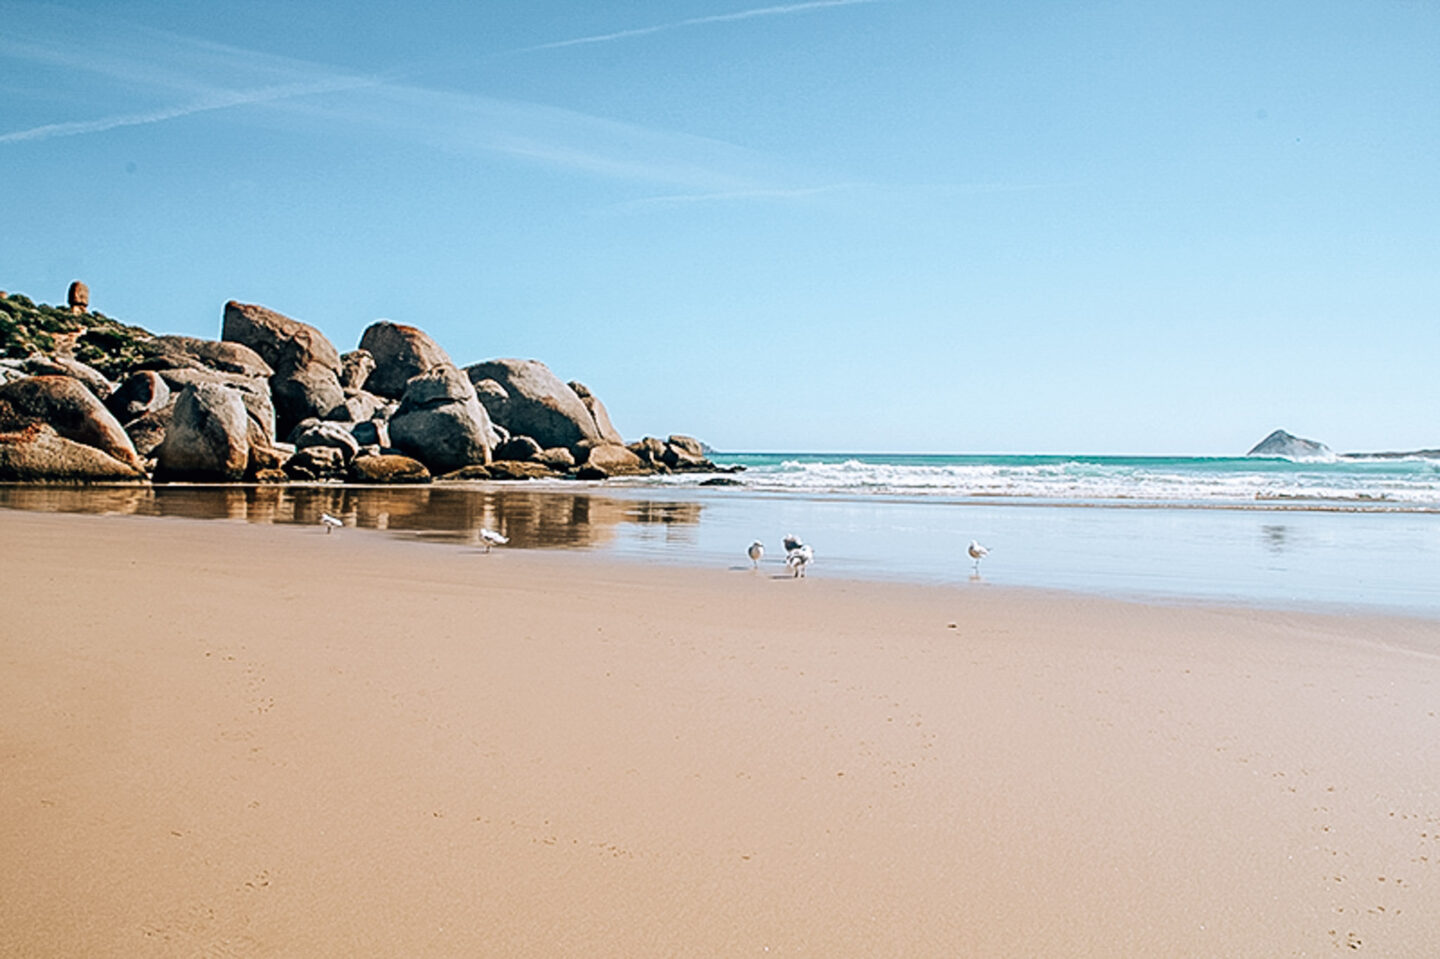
[465, 360, 609, 458]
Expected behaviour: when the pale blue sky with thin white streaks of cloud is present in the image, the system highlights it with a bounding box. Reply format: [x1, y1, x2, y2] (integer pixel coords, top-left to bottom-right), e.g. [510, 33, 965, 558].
[0, 0, 1440, 454]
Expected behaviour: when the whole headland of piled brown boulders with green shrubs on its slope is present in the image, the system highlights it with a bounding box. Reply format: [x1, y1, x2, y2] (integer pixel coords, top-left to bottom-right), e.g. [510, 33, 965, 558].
[0, 281, 724, 484]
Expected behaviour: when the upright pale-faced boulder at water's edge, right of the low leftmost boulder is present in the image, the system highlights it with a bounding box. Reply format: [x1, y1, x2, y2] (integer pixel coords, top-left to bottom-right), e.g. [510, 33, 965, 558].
[156, 383, 251, 482]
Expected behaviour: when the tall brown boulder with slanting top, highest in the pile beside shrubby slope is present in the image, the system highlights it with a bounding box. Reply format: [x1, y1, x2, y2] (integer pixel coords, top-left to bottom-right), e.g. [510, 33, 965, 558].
[220, 300, 346, 435]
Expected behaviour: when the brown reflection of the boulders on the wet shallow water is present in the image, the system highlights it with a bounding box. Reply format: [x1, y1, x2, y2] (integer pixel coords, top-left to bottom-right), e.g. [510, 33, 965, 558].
[0, 485, 703, 549]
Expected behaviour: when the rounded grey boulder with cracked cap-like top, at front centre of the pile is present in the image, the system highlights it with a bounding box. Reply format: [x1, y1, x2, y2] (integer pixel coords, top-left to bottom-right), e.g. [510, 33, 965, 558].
[390, 366, 500, 474]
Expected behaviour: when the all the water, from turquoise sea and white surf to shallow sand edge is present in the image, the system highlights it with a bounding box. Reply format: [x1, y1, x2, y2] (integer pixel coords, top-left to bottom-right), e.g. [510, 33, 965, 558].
[0, 454, 1440, 618]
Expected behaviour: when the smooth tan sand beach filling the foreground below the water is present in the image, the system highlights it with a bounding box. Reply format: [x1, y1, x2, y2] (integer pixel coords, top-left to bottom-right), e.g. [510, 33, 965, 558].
[0, 511, 1440, 958]
